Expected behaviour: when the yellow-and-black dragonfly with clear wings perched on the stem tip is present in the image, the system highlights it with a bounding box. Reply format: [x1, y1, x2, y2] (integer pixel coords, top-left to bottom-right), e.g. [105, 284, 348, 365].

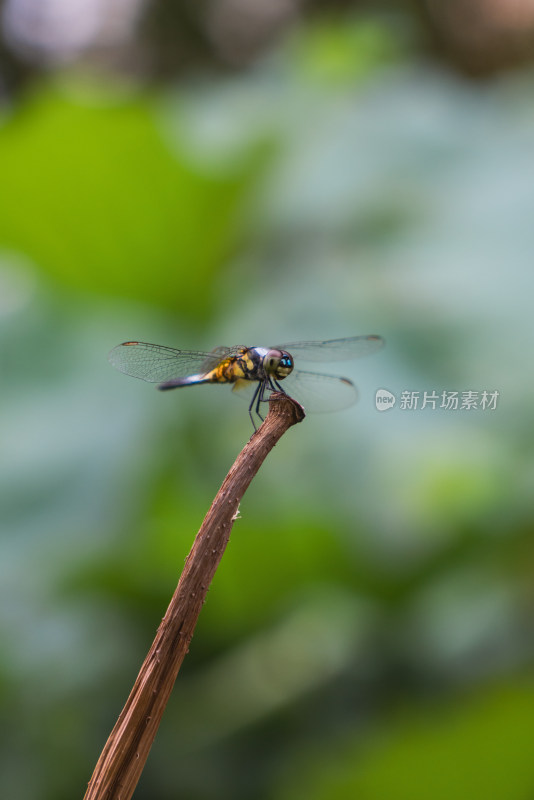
[109, 335, 384, 428]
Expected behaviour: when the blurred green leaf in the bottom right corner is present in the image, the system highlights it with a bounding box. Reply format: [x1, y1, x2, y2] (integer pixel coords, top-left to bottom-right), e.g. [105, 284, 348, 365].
[278, 684, 534, 800]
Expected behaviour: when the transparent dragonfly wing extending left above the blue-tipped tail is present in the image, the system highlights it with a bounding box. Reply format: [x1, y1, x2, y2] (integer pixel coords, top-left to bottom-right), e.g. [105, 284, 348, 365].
[109, 342, 238, 383]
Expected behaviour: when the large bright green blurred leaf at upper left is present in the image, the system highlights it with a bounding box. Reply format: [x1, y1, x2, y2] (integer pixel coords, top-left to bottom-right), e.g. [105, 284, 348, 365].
[0, 83, 263, 317]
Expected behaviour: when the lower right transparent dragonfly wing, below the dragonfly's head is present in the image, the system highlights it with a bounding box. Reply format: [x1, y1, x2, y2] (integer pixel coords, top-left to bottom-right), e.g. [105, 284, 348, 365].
[280, 369, 358, 412]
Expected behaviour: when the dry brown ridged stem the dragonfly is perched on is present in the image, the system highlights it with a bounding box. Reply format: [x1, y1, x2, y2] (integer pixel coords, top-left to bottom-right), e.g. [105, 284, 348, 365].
[84, 392, 304, 800]
